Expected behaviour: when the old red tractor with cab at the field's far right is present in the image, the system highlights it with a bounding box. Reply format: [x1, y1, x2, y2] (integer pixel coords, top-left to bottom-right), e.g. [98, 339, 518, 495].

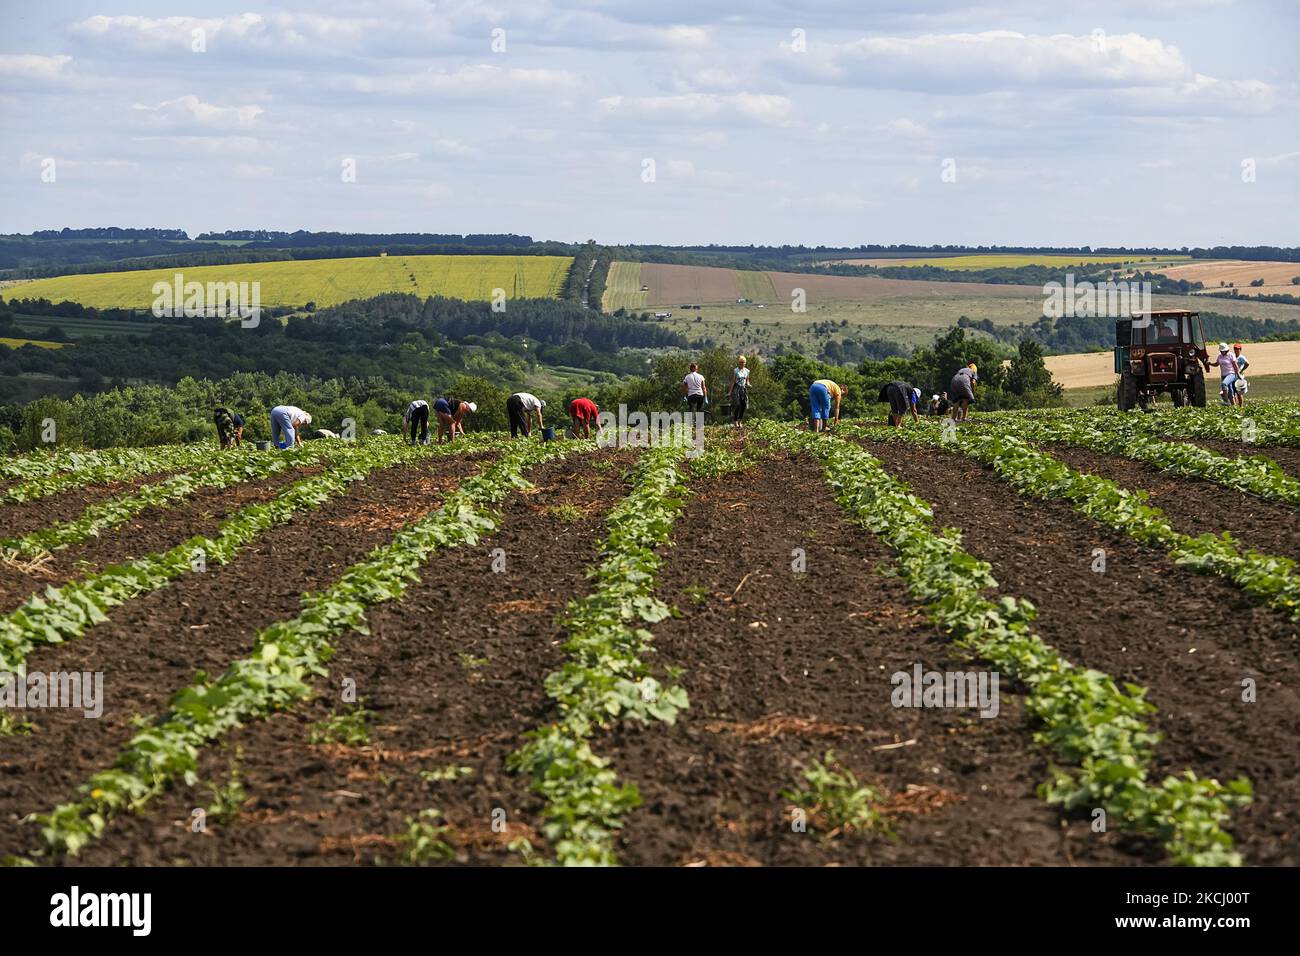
[1115, 310, 1210, 411]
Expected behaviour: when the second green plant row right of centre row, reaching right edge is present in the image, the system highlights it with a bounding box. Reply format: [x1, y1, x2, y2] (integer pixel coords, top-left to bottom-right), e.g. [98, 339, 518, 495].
[849, 427, 1300, 622]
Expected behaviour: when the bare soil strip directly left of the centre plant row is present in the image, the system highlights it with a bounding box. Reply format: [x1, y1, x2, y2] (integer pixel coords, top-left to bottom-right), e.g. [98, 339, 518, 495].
[78, 453, 631, 866]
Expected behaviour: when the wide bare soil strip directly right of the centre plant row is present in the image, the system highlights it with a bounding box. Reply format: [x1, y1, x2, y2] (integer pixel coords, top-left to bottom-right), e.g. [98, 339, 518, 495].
[593, 453, 1134, 866]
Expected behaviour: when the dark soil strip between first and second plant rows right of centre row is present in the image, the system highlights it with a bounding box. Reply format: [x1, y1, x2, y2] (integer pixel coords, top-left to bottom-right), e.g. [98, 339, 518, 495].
[852, 441, 1300, 865]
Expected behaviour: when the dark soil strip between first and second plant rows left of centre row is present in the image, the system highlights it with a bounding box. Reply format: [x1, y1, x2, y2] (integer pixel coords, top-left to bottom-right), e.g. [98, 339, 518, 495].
[0, 453, 483, 856]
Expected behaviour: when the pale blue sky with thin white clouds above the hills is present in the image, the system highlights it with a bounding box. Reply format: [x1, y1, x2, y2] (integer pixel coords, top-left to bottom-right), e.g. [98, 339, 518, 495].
[0, 0, 1300, 247]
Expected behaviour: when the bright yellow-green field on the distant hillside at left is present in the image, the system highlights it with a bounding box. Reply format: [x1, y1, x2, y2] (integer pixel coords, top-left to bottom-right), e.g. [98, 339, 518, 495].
[5, 256, 573, 310]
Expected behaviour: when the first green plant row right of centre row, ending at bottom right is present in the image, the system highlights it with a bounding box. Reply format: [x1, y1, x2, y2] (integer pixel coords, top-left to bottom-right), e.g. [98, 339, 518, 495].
[759, 423, 1252, 866]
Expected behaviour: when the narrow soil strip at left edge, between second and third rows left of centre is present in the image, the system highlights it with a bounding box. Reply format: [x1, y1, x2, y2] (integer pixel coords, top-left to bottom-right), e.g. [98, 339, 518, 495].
[0, 466, 321, 613]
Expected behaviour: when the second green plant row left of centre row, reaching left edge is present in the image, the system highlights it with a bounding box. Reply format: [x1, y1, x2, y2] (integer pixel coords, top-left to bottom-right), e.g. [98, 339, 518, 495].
[0, 438, 491, 671]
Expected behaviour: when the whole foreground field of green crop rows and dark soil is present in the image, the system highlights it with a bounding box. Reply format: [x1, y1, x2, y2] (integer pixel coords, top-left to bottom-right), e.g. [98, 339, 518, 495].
[0, 405, 1300, 866]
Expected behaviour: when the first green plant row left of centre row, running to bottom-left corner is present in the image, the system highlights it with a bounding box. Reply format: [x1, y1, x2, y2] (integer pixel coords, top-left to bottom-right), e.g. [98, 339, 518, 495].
[22, 442, 574, 855]
